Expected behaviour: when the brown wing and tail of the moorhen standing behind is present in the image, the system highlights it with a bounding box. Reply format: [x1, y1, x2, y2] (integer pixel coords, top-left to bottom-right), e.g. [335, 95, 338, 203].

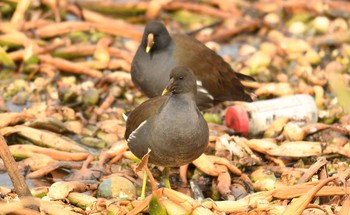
[172, 34, 254, 102]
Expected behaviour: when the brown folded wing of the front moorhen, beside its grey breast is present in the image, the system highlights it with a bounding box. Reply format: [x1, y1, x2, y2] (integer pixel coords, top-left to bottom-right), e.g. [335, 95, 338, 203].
[124, 96, 168, 140]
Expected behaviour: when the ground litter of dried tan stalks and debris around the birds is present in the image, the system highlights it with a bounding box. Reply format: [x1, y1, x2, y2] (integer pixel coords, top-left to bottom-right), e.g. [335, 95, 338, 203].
[0, 0, 350, 214]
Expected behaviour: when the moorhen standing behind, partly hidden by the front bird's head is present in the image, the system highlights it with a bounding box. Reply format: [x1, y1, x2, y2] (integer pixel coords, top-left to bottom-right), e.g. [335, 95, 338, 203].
[131, 21, 254, 110]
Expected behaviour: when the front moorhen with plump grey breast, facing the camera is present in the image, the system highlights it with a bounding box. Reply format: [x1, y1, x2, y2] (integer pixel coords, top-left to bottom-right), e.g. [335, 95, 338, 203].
[125, 66, 209, 167]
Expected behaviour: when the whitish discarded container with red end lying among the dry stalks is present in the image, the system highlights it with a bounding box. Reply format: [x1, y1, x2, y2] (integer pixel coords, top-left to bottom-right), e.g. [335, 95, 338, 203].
[225, 94, 317, 136]
